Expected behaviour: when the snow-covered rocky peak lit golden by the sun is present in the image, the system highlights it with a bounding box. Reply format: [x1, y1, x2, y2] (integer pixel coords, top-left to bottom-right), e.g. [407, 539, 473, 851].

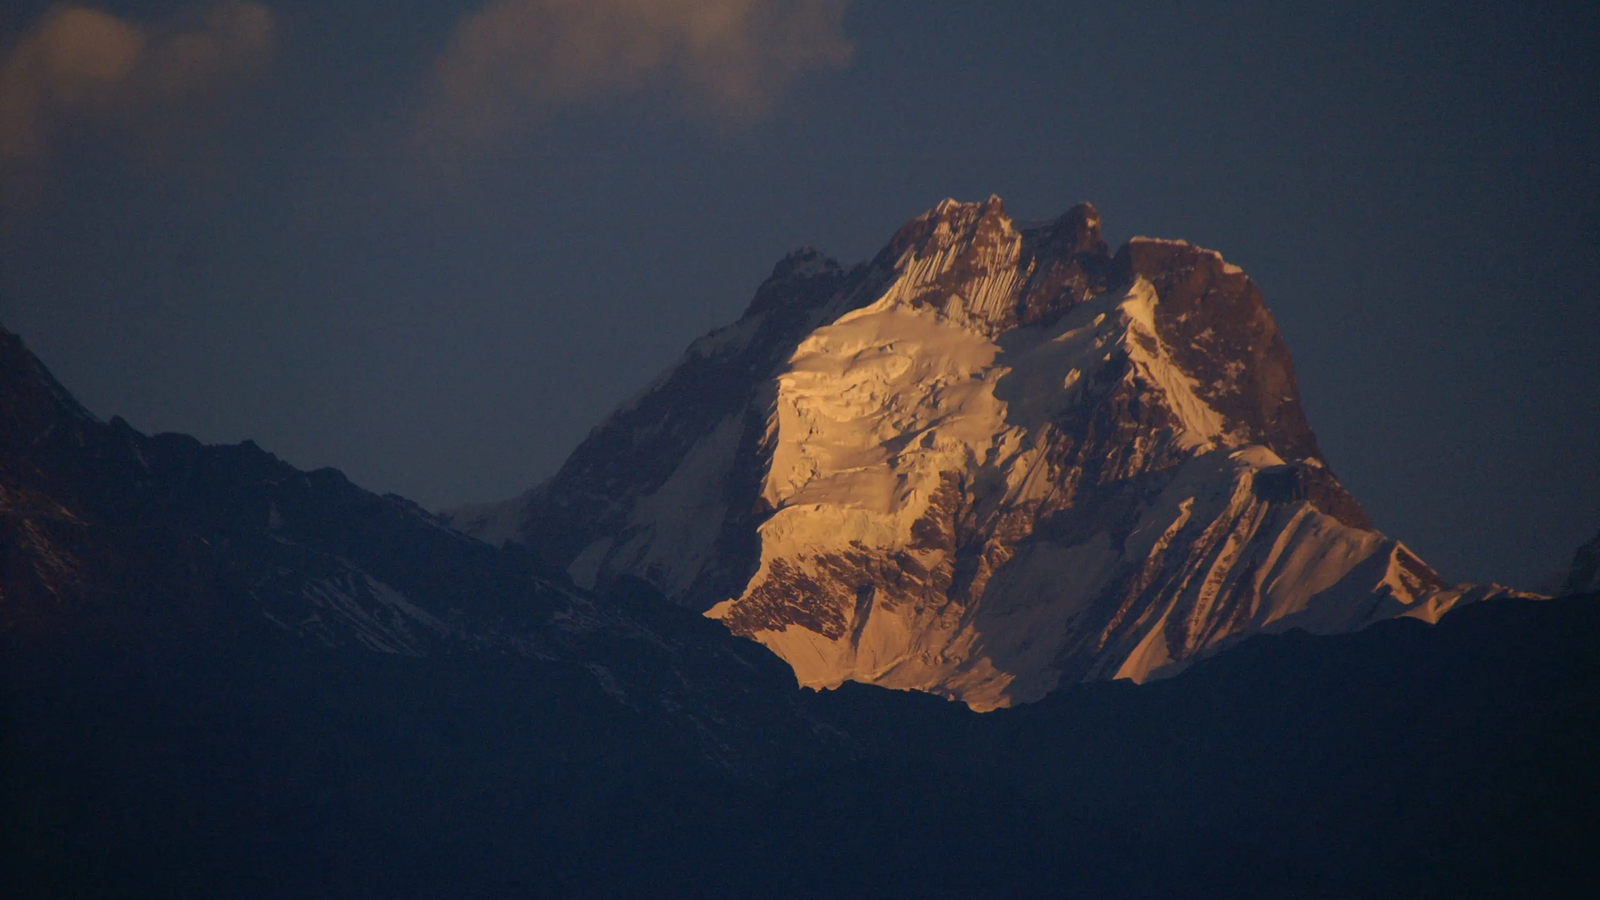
[448, 197, 1523, 709]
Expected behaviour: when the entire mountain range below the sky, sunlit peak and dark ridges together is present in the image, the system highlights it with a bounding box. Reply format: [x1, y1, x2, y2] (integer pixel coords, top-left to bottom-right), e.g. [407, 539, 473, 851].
[0, 202, 1600, 900]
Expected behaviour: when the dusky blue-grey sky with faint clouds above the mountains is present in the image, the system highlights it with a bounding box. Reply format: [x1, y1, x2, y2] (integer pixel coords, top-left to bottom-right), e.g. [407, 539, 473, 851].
[0, 0, 1600, 588]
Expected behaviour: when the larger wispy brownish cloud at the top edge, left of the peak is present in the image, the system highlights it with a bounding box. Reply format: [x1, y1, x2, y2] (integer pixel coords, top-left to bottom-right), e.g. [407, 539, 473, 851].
[414, 0, 851, 147]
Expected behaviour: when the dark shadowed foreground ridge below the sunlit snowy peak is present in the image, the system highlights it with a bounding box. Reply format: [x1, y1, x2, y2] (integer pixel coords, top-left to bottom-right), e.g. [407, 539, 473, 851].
[0, 222, 1600, 898]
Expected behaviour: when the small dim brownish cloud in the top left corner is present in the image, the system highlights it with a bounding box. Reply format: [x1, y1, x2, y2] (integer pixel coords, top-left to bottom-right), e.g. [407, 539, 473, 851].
[0, 0, 274, 165]
